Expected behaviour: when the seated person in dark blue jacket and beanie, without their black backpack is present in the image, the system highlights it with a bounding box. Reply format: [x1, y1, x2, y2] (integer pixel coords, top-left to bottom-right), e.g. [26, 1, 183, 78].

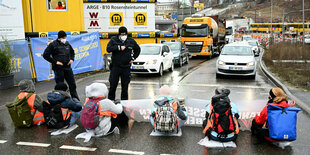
[47, 82, 82, 127]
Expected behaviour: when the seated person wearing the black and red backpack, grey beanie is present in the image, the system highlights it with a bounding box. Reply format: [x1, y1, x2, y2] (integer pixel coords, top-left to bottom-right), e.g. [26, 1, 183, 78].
[203, 87, 239, 142]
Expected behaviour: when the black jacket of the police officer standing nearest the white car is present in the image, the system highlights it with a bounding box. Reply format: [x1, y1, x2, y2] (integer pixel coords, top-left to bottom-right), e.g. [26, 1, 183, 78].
[107, 36, 140, 68]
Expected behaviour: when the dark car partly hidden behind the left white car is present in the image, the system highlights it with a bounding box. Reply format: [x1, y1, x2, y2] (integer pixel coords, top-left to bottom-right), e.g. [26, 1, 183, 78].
[164, 42, 189, 67]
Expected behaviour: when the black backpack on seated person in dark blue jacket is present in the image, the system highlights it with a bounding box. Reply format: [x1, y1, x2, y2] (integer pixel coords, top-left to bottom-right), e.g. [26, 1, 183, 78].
[43, 101, 68, 129]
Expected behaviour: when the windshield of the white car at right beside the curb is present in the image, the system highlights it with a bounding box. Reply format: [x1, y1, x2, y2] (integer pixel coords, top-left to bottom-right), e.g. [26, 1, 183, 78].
[221, 46, 253, 56]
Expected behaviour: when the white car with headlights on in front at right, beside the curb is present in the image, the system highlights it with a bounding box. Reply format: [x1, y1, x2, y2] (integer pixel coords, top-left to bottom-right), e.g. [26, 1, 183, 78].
[216, 43, 257, 79]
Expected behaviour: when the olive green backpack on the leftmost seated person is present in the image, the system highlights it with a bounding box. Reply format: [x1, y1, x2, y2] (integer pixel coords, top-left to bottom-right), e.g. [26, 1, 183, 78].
[6, 93, 33, 128]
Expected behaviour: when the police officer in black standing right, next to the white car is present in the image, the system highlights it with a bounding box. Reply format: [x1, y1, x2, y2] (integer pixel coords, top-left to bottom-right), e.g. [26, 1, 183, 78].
[107, 26, 140, 100]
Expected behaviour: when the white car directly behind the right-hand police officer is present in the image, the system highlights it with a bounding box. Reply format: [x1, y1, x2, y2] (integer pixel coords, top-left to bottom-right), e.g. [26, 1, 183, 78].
[131, 44, 174, 76]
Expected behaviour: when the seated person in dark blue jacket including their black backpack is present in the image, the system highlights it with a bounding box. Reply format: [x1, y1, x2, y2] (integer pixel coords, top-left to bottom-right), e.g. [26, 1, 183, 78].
[43, 83, 82, 129]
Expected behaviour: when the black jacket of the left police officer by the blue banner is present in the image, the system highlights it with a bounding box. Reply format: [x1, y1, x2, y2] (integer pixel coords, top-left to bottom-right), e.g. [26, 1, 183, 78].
[43, 40, 75, 69]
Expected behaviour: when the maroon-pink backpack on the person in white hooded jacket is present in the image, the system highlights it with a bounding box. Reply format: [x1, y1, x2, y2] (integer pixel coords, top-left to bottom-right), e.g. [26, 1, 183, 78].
[81, 99, 100, 129]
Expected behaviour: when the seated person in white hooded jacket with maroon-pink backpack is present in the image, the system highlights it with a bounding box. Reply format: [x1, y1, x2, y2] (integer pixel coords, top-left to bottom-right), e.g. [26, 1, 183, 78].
[76, 83, 123, 142]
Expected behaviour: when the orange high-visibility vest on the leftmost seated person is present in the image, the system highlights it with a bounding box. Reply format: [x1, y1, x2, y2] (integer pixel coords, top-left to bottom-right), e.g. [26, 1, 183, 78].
[18, 92, 45, 125]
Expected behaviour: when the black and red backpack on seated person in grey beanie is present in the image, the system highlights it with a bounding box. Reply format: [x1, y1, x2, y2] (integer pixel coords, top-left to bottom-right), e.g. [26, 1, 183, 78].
[211, 97, 236, 140]
